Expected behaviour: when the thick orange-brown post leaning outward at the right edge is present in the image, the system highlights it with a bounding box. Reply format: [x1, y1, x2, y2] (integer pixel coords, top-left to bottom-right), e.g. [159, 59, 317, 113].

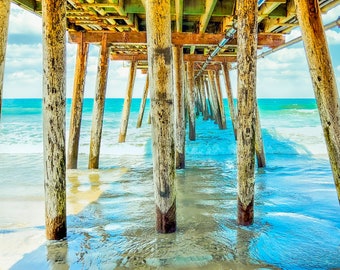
[294, 0, 340, 203]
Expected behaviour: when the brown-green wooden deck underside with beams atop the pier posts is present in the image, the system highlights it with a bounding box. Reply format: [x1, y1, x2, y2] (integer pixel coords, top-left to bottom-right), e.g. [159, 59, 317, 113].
[12, 0, 340, 73]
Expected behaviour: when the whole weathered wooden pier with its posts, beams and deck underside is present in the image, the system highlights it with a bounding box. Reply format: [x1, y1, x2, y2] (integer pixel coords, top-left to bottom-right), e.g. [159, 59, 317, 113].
[0, 0, 340, 239]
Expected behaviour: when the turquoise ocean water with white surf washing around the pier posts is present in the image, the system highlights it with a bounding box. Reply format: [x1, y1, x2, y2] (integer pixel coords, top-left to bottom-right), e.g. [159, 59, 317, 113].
[0, 99, 340, 269]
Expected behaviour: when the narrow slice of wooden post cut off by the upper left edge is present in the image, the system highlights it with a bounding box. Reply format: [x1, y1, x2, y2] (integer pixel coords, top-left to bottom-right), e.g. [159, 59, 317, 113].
[0, 0, 11, 119]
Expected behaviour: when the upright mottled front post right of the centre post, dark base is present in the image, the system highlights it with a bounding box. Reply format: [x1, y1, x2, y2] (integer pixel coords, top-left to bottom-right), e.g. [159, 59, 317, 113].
[237, 0, 258, 225]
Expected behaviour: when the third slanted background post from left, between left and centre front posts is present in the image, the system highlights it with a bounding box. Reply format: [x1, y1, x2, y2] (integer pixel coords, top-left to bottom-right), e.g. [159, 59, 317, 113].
[118, 61, 137, 143]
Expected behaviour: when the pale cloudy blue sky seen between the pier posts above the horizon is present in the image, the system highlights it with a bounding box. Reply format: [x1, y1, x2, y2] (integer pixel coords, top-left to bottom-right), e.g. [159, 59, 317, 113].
[3, 3, 340, 98]
